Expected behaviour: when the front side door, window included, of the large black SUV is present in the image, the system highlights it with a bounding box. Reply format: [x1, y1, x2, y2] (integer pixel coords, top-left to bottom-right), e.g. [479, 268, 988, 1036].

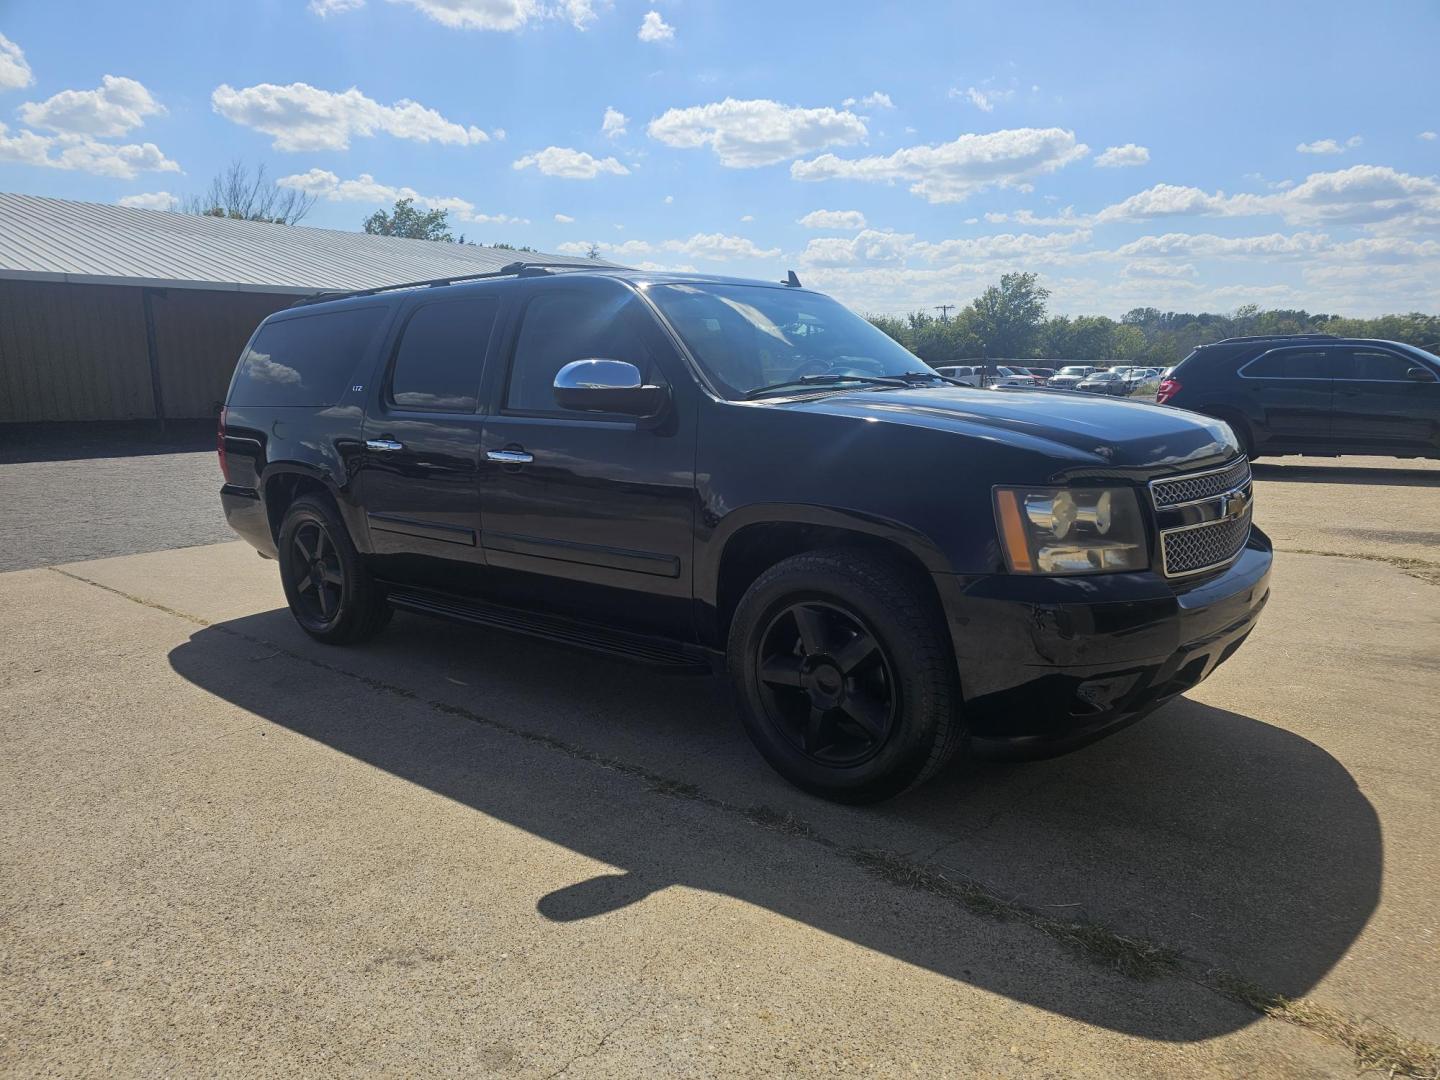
[480, 275, 698, 635]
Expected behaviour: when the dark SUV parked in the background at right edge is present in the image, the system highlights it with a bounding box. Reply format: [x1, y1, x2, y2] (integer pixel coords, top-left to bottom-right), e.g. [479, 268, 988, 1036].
[1156, 334, 1440, 458]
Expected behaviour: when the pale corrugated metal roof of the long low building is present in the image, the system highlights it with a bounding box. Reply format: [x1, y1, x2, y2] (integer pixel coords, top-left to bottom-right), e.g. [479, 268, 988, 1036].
[0, 192, 611, 294]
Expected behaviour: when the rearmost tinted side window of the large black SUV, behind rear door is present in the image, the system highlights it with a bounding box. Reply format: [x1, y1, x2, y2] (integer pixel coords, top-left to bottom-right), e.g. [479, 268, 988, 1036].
[230, 307, 386, 405]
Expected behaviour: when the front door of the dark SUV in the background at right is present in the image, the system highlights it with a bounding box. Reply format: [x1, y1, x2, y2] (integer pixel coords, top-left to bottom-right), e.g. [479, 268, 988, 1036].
[1331, 346, 1440, 452]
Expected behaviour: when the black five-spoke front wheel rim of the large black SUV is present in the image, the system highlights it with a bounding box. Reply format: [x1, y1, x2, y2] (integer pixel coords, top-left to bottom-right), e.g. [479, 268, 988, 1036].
[756, 600, 899, 768]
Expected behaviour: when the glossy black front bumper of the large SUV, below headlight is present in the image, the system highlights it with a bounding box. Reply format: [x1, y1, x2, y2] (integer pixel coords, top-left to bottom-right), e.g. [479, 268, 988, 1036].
[936, 528, 1273, 756]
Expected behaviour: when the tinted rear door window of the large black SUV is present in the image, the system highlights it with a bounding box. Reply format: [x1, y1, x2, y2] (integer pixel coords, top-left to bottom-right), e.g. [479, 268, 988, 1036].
[390, 297, 498, 412]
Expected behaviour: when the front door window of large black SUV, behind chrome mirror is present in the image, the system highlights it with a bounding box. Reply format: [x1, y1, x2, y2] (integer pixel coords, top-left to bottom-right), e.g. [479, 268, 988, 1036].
[505, 287, 661, 412]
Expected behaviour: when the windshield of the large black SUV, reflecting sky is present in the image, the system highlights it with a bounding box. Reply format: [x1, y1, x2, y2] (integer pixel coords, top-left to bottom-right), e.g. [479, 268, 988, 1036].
[648, 282, 940, 397]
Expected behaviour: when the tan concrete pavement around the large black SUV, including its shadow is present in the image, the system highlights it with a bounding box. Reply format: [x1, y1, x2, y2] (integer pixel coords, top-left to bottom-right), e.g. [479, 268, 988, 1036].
[0, 462, 1440, 1076]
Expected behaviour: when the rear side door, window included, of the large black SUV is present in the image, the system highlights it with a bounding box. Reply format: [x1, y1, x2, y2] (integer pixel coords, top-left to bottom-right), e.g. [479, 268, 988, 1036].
[357, 294, 498, 586]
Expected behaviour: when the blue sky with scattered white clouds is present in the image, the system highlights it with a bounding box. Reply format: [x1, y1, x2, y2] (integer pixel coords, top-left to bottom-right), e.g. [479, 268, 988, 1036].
[0, 0, 1440, 315]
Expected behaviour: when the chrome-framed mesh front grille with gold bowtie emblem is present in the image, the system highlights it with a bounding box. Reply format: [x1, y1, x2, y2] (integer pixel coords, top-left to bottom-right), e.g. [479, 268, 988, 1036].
[1151, 458, 1253, 577]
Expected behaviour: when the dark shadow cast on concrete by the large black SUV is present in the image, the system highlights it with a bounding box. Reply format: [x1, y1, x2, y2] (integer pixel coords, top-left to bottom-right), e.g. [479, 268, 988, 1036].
[170, 611, 1381, 1041]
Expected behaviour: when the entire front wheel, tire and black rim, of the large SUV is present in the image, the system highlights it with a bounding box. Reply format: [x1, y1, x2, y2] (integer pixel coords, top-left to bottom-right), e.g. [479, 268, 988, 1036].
[729, 550, 962, 804]
